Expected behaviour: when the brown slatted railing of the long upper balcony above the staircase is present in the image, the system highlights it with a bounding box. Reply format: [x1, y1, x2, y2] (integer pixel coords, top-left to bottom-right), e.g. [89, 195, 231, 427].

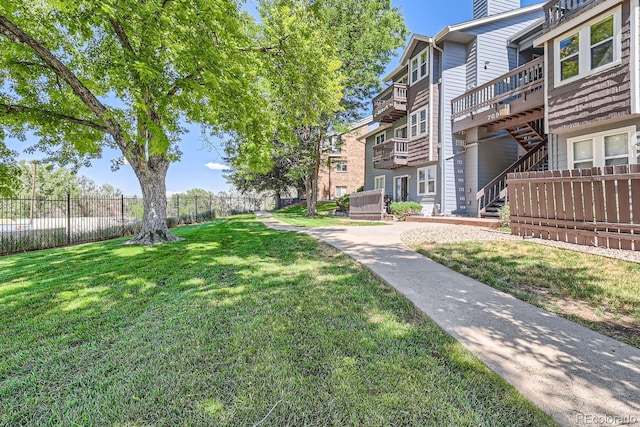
[451, 57, 544, 121]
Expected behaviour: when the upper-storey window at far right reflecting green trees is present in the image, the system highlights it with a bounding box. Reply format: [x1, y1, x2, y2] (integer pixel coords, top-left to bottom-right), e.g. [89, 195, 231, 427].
[555, 7, 622, 84]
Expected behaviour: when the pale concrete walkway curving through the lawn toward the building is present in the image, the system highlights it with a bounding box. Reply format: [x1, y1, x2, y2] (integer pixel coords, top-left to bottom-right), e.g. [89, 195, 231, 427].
[258, 215, 640, 426]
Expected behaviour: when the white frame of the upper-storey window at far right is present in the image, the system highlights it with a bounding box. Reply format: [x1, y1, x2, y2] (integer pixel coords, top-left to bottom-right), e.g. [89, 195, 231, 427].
[553, 6, 622, 87]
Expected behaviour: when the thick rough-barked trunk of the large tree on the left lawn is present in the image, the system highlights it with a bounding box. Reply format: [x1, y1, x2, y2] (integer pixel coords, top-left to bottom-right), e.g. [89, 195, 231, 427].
[127, 160, 182, 245]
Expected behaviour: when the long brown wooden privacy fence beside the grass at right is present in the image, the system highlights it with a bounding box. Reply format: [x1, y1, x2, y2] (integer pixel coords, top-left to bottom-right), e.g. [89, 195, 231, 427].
[507, 165, 640, 251]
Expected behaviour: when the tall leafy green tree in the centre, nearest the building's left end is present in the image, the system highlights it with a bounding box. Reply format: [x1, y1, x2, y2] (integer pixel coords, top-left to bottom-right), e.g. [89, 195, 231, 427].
[228, 0, 407, 216]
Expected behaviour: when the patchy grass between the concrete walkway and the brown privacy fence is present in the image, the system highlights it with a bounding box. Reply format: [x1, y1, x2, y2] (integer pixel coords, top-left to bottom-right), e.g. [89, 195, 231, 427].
[418, 242, 640, 348]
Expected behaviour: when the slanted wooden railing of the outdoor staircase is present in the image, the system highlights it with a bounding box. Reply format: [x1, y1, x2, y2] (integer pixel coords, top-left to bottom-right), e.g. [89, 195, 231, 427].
[476, 141, 548, 217]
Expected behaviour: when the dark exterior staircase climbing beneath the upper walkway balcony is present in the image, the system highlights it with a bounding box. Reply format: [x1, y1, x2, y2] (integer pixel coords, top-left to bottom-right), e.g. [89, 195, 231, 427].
[476, 120, 549, 218]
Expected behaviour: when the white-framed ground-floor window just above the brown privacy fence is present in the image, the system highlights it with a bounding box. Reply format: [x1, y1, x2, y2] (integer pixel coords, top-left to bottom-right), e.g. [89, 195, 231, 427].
[567, 126, 636, 169]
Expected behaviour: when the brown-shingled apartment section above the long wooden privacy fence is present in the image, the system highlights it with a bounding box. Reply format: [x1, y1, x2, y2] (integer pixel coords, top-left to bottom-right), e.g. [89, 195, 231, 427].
[535, 0, 640, 170]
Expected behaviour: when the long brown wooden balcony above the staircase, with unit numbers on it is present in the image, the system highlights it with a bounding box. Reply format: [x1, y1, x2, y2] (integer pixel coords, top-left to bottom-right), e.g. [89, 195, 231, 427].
[451, 58, 544, 133]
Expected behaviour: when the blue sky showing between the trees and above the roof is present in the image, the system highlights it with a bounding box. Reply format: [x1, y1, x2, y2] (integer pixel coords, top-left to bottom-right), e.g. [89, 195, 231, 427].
[7, 0, 539, 196]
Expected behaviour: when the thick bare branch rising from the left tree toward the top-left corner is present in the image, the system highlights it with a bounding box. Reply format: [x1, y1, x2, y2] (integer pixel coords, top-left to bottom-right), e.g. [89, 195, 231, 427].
[0, 15, 126, 140]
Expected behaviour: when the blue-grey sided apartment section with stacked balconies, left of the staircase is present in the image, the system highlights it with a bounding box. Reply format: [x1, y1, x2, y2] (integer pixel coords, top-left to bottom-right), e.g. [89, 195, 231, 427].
[363, 0, 543, 215]
